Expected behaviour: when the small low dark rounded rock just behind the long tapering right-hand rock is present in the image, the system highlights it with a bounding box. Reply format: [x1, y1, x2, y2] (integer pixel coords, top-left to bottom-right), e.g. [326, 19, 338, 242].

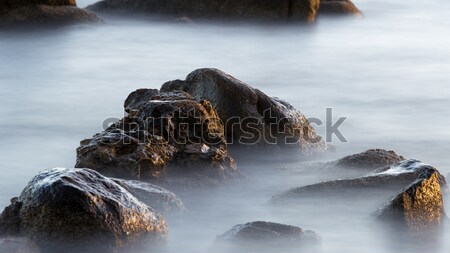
[333, 149, 405, 170]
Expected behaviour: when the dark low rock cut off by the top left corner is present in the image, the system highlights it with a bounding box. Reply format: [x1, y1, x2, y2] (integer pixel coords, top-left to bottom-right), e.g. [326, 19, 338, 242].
[0, 0, 101, 28]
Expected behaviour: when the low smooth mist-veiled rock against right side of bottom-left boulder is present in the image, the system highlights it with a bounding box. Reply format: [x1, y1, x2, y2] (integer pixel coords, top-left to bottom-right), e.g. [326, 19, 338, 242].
[113, 179, 186, 214]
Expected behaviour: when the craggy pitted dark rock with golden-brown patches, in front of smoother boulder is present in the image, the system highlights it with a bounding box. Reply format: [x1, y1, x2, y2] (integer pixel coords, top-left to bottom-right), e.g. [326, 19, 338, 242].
[75, 89, 239, 185]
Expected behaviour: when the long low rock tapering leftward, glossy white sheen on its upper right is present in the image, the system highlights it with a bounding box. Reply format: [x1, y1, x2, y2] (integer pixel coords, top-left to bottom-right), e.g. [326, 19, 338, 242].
[272, 159, 448, 202]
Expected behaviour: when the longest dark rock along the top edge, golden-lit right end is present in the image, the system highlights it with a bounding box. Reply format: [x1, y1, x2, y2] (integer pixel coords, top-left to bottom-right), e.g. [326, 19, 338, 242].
[88, 0, 320, 22]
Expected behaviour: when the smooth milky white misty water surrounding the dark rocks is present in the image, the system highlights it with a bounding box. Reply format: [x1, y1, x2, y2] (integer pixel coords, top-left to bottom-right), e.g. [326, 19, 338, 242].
[0, 0, 450, 253]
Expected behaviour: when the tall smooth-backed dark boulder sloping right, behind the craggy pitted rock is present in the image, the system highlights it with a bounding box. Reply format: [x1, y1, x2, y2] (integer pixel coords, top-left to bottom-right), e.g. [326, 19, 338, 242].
[161, 69, 326, 154]
